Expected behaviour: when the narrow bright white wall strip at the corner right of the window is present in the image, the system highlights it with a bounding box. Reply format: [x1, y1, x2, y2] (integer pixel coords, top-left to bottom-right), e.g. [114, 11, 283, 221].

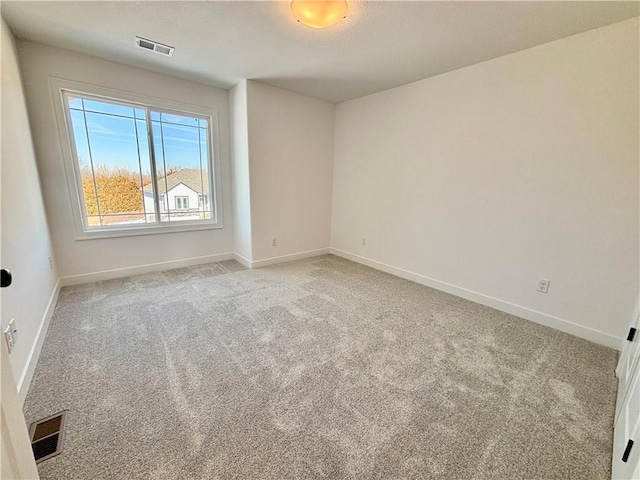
[229, 80, 253, 263]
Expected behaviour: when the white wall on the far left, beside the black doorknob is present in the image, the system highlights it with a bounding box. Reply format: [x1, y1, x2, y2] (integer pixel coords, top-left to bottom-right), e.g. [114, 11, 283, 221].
[0, 20, 57, 398]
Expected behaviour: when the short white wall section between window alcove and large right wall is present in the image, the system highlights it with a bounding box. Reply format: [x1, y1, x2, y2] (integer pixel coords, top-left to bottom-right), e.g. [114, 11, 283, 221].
[247, 81, 335, 261]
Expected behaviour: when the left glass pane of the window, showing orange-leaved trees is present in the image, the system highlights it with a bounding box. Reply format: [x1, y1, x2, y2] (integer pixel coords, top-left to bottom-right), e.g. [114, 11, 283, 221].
[70, 96, 155, 228]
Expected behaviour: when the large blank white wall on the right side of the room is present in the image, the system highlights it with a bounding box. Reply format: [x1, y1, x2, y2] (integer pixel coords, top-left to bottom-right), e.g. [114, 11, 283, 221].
[332, 19, 639, 347]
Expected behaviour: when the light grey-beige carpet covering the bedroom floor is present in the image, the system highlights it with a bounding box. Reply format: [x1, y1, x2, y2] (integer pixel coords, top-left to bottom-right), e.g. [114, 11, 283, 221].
[25, 256, 617, 480]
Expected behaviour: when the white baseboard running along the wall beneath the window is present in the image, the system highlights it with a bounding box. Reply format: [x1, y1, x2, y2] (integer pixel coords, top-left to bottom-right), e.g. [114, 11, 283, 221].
[60, 253, 236, 287]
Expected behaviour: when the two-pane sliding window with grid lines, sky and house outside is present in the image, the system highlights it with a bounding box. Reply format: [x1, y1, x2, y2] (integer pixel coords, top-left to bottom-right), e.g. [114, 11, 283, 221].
[55, 81, 221, 239]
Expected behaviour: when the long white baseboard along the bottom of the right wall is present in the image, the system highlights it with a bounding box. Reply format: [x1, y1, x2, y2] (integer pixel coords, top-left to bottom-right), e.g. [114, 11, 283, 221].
[330, 248, 622, 350]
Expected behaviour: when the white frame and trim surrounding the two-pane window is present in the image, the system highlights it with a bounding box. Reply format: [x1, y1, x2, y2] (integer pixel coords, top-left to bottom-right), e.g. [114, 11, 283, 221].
[49, 77, 223, 240]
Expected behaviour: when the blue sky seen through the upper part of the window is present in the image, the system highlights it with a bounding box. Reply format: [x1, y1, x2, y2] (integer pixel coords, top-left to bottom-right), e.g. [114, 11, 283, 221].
[69, 98, 208, 175]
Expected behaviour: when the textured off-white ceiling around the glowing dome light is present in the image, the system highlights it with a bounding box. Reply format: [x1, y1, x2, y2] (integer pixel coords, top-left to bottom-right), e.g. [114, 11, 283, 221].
[1, 1, 640, 103]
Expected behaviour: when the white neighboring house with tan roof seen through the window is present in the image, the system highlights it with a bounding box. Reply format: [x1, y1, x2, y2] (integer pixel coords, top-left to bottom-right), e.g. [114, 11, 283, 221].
[142, 168, 210, 214]
